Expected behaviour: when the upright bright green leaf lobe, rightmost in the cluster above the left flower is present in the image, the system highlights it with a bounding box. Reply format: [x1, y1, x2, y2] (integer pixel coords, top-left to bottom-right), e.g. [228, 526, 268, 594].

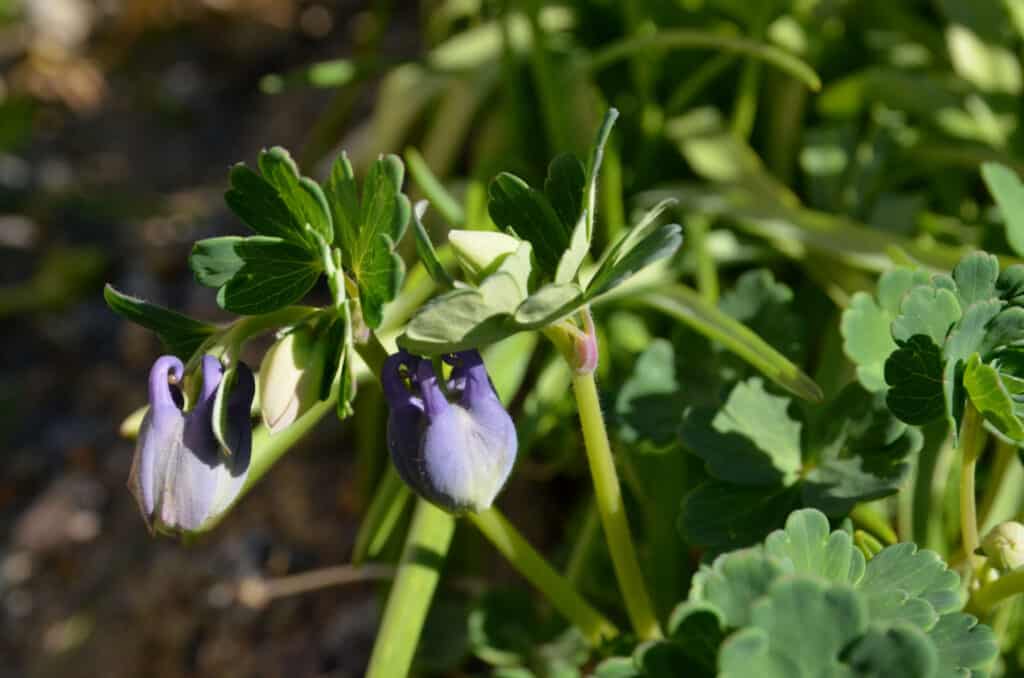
[351, 156, 412, 328]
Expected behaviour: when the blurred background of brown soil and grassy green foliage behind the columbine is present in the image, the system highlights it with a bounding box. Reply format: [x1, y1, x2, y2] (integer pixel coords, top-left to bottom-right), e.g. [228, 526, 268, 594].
[0, 0, 1024, 678]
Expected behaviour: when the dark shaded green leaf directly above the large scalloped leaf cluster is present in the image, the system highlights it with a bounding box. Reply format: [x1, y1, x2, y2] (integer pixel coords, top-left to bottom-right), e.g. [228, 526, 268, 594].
[679, 480, 800, 553]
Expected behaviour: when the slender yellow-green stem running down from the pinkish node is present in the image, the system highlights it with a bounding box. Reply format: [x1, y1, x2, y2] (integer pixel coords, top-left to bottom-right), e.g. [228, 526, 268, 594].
[572, 373, 662, 640]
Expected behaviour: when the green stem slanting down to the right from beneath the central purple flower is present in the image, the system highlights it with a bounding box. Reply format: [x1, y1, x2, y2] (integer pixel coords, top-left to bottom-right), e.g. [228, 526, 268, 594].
[466, 508, 618, 645]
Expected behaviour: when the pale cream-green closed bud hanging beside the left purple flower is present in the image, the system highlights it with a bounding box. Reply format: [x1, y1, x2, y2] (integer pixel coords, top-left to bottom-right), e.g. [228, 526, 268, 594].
[259, 325, 329, 433]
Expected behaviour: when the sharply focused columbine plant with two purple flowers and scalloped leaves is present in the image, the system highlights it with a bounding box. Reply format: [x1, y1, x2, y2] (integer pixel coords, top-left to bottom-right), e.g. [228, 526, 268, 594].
[105, 110, 1024, 678]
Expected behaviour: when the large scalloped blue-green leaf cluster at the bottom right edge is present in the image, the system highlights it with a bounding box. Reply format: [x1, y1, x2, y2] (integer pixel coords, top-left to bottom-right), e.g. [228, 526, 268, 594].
[595, 509, 998, 678]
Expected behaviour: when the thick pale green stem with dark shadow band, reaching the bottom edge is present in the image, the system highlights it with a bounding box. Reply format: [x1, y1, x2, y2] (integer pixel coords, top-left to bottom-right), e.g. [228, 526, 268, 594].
[366, 499, 455, 678]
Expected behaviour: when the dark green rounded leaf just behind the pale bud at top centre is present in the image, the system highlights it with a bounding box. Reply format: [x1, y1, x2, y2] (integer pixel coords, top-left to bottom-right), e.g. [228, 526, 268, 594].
[487, 172, 571, 277]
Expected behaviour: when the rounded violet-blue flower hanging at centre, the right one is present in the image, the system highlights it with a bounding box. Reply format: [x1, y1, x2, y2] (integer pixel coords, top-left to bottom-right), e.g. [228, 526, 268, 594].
[381, 350, 518, 512]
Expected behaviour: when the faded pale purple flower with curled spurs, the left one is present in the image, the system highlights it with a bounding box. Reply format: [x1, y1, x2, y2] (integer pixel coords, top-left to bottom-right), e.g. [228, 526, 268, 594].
[128, 355, 256, 533]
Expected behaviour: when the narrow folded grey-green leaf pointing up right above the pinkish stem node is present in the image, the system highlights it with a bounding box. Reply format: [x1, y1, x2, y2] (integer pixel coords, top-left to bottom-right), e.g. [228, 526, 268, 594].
[587, 200, 683, 299]
